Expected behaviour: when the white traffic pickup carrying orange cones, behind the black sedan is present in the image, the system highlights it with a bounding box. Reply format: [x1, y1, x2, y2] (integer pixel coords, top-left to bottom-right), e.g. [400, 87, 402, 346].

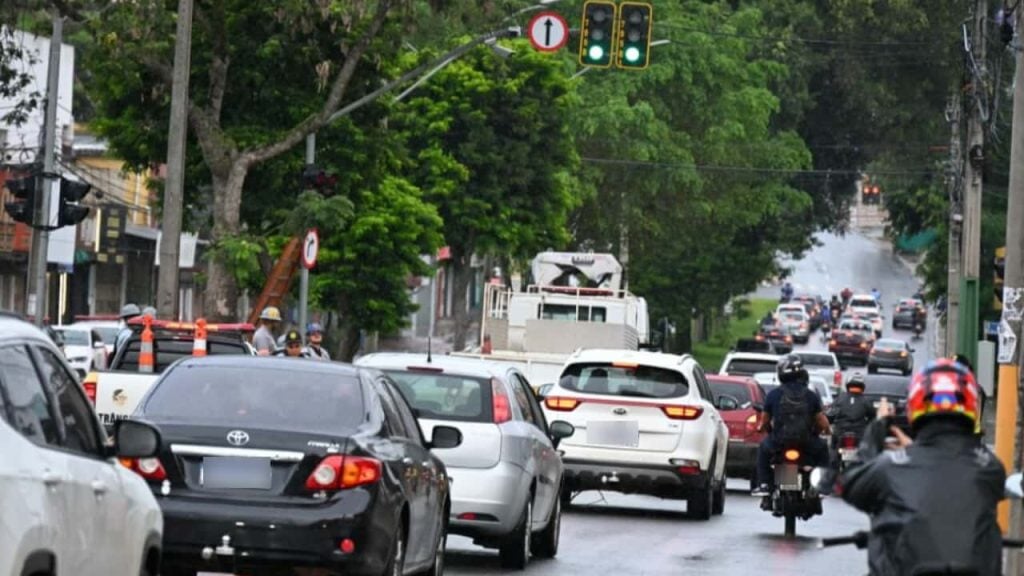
[82, 320, 255, 427]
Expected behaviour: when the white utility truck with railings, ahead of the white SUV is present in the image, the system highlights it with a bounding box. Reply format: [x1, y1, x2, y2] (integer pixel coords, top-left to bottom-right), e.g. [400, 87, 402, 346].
[453, 252, 650, 389]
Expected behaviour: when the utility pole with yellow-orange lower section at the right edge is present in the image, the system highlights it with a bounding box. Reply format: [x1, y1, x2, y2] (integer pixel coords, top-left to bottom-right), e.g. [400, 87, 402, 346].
[995, 4, 1024, 561]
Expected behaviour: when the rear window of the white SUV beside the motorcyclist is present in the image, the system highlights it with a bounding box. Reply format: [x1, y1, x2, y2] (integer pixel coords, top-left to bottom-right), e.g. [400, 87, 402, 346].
[559, 363, 690, 398]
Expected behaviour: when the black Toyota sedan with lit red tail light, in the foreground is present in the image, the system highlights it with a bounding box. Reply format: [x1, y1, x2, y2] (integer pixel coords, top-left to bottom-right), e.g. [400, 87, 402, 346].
[125, 356, 462, 576]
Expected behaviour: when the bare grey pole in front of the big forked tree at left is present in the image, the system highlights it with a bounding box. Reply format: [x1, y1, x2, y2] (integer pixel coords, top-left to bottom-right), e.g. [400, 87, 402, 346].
[157, 0, 193, 319]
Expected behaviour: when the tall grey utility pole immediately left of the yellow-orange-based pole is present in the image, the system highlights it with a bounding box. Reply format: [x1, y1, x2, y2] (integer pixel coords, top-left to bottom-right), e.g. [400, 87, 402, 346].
[956, 0, 988, 362]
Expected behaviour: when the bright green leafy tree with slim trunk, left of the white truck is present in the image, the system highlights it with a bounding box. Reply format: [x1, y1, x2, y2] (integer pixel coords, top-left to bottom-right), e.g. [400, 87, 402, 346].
[392, 42, 577, 349]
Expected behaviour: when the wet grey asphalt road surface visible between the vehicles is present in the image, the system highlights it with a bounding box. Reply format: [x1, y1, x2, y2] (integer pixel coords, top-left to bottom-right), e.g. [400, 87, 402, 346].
[445, 228, 935, 576]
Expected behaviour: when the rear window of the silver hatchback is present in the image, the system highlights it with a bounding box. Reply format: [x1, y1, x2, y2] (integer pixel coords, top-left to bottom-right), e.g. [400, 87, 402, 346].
[385, 370, 492, 422]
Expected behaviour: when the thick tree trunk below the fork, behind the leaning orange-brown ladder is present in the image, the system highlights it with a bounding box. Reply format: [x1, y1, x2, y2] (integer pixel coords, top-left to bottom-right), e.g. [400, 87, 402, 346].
[203, 161, 249, 322]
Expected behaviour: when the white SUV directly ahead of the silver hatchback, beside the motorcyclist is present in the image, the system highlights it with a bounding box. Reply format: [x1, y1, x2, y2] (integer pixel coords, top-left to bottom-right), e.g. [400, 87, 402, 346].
[544, 349, 735, 520]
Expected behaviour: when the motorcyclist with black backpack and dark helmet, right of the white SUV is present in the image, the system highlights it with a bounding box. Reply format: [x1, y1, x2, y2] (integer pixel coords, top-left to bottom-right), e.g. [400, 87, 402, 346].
[752, 354, 830, 496]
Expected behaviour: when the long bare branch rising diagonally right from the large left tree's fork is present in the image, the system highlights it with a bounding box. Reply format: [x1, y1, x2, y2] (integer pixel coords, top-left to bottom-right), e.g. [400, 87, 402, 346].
[243, 0, 393, 165]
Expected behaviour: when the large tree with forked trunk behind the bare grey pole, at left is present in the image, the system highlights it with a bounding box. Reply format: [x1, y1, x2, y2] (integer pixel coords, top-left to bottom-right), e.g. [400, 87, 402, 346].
[82, 0, 409, 319]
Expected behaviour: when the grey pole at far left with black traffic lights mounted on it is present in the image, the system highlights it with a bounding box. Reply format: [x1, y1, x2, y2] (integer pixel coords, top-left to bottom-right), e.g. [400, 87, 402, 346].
[26, 9, 63, 326]
